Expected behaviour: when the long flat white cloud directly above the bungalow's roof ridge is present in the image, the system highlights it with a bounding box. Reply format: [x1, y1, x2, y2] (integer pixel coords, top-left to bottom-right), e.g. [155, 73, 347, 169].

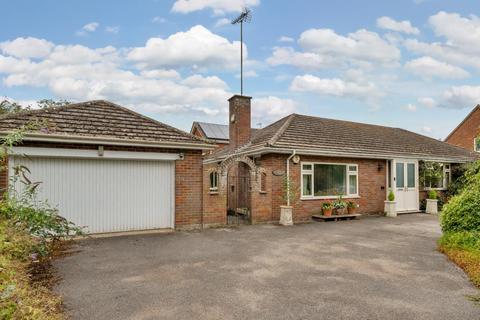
[290, 74, 379, 99]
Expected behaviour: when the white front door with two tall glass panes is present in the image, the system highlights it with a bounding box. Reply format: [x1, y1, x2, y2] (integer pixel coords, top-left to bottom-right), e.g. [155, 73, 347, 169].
[393, 159, 419, 211]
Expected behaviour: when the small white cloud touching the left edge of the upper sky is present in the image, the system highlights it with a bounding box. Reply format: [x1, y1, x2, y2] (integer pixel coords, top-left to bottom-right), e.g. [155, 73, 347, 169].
[0, 37, 53, 58]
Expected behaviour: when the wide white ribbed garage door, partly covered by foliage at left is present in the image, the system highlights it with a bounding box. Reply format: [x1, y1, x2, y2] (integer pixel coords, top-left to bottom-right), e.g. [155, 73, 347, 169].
[10, 157, 175, 233]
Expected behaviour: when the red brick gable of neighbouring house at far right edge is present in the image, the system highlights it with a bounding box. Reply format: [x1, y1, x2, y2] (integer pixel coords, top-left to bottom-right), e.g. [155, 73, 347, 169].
[445, 105, 480, 152]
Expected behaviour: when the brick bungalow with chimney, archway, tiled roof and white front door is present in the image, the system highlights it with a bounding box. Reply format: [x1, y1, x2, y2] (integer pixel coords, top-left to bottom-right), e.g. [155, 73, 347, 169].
[203, 95, 475, 224]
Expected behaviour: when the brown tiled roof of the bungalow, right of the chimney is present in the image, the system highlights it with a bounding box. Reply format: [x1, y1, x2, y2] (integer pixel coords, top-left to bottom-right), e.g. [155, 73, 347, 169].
[207, 114, 477, 162]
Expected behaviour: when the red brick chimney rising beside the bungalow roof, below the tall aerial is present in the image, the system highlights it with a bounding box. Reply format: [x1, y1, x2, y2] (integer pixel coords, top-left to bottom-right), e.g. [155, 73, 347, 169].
[228, 95, 252, 149]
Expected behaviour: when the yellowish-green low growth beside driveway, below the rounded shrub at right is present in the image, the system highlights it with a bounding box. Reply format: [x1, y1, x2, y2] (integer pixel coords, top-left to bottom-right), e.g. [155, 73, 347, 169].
[439, 232, 480, 288]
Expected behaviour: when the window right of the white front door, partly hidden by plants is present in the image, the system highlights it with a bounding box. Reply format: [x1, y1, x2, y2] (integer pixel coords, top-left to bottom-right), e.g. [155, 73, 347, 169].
[419, 161, 451, 189]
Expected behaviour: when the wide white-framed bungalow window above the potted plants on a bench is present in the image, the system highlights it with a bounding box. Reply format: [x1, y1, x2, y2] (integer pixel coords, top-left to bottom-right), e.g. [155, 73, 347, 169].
[301, 163, 358, 198]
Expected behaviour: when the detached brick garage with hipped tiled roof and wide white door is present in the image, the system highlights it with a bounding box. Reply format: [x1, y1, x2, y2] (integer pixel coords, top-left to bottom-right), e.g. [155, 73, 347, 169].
[0, 100, 215, 233]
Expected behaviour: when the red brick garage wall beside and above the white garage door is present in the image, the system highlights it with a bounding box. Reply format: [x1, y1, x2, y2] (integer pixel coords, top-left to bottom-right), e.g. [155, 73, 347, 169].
[0, 141, 203, 229]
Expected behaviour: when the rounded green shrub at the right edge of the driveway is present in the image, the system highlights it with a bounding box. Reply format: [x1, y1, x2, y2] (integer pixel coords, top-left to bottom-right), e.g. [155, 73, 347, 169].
[440, 182, 480, 232]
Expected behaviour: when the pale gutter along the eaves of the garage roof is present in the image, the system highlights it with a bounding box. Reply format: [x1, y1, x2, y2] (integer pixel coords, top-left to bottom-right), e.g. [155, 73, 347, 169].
[0, 132, 215, 150]
